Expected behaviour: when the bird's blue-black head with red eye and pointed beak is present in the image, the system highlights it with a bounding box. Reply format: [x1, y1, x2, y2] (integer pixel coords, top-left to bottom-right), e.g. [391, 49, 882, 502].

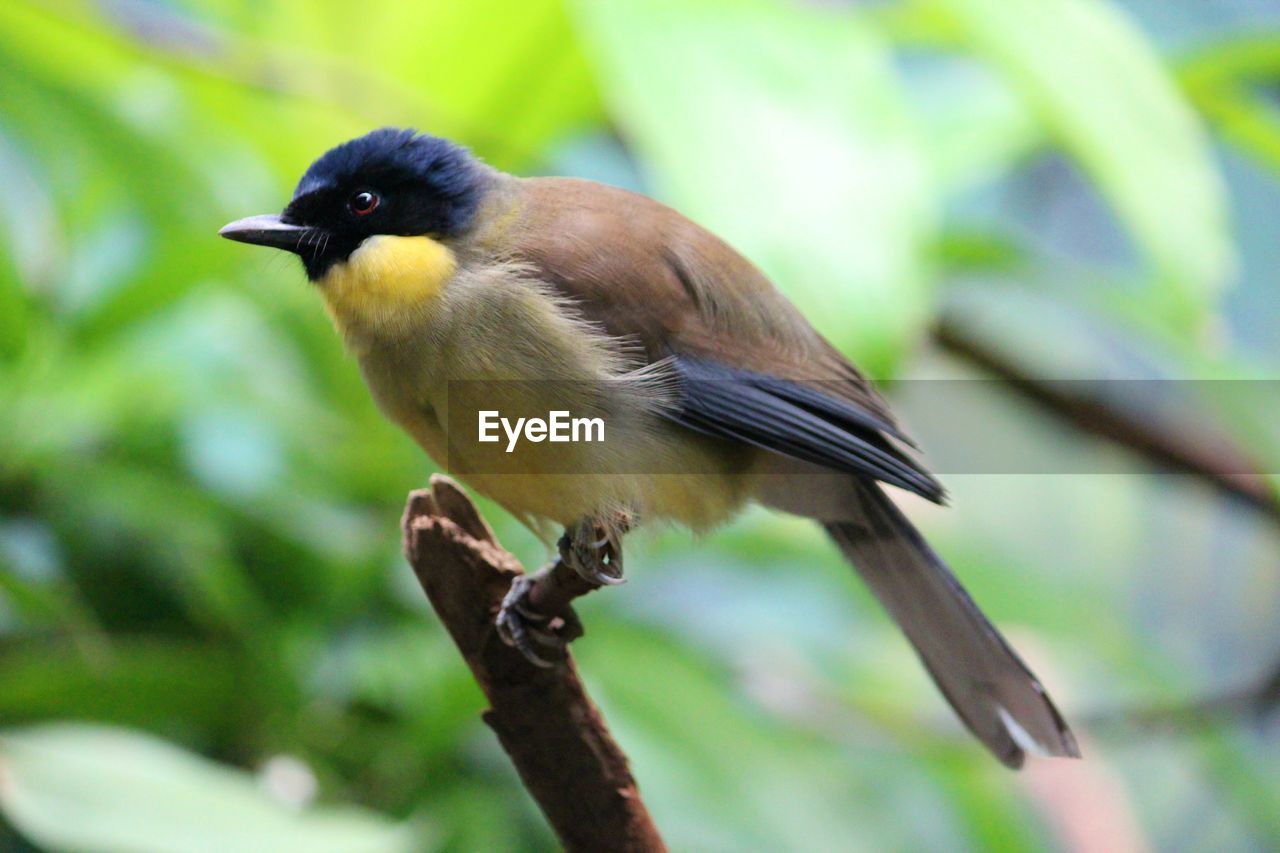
[219, 128, 488, 282]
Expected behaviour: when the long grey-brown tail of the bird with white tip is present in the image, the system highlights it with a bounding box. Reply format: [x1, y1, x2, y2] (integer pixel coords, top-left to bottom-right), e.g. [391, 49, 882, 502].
[823, 480, 1080, 768]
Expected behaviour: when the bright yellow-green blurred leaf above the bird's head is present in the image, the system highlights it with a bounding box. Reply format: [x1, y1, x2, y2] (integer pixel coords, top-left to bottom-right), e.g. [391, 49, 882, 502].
[195, 0, 600, 168]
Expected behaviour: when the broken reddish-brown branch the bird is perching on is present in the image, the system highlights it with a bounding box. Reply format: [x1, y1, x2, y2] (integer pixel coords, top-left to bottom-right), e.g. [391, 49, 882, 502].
[402, 475, 666, 852]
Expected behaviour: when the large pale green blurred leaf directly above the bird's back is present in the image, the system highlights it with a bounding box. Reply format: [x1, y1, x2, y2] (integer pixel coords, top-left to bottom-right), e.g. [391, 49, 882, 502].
[579, 0, 934, 374]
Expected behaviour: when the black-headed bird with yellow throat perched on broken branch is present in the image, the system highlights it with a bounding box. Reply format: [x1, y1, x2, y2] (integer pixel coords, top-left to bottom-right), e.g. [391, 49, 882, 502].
[220, 129, 1079, 767]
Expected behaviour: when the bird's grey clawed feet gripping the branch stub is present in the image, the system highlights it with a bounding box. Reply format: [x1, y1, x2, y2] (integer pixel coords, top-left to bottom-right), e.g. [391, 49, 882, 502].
[495, 514, 630, 666]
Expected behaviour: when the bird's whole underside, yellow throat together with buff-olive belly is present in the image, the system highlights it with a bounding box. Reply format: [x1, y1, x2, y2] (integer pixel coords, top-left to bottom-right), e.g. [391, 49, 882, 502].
[320, 237, 750, 528]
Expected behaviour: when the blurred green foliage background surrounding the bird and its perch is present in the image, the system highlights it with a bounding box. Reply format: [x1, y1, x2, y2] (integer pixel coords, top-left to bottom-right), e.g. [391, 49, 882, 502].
[0, 0, 1280, 852]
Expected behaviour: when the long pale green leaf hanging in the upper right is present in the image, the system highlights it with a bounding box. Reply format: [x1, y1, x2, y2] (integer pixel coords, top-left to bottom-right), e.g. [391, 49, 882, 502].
[936, 0, 1235, 328]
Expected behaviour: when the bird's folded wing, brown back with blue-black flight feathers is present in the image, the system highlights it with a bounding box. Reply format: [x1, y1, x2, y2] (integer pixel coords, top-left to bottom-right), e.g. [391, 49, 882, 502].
[513, 178, 942, 500]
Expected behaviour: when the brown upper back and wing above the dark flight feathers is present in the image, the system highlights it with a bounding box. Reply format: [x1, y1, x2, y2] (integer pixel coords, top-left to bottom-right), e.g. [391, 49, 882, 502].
[517, 178, 895, 424]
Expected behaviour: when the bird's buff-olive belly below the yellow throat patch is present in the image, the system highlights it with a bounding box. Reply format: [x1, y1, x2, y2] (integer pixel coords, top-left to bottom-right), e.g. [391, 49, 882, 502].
[358, 266, 753, 529]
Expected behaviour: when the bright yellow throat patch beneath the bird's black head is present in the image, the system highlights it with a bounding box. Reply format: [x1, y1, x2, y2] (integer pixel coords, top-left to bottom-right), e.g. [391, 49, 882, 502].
[320, 234, 458, 339]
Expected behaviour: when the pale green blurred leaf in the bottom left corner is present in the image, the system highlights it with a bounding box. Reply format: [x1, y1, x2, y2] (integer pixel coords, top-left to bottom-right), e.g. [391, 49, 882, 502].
[0, 725, 421, 853]
